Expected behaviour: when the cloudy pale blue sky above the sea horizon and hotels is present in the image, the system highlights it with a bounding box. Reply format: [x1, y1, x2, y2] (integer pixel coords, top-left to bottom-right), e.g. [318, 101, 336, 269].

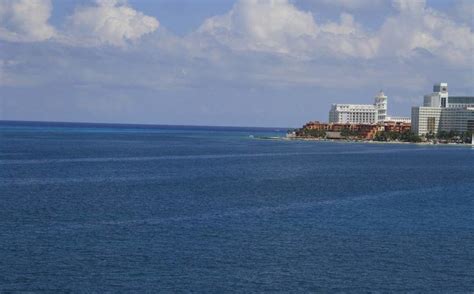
[0, 0, 474, 127]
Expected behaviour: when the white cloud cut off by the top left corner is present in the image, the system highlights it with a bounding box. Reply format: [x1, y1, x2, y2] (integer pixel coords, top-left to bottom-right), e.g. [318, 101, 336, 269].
[0, 0, 56, 42]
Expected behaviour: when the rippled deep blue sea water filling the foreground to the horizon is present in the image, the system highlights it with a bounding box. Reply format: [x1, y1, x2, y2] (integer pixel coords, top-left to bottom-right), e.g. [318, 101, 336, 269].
[0, 122, 474, 293]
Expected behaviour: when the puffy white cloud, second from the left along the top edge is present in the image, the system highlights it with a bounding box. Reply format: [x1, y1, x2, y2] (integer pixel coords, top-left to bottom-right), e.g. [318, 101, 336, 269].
[67, 0, 159, 46]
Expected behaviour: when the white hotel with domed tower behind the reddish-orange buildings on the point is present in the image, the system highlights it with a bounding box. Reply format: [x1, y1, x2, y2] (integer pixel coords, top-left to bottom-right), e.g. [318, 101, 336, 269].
[329, 91, 410, 124]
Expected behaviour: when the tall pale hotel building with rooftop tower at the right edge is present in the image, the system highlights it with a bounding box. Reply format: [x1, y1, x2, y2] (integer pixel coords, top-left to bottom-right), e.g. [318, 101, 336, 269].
[411, 83, 474, 135]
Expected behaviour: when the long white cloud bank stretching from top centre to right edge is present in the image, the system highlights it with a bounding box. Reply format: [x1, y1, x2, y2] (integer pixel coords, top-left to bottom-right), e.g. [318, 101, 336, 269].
[198, 0, 474, 64]
